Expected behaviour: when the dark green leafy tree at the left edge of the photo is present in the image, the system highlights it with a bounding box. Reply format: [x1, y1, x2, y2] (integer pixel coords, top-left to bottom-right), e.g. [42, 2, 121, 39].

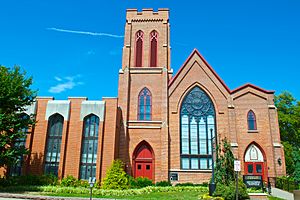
[0, 66, 36, 173]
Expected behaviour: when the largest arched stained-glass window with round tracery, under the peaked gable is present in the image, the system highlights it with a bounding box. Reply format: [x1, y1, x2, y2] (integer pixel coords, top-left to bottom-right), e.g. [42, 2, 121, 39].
[180, 86, 216, 170]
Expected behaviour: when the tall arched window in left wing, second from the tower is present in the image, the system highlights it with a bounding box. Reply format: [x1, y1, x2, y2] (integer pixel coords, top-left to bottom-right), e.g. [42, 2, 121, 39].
[45, 114, 64, 176]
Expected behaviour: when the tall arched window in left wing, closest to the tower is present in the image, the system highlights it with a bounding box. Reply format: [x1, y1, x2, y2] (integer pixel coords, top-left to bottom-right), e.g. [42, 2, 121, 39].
[80, 114, 99, 180]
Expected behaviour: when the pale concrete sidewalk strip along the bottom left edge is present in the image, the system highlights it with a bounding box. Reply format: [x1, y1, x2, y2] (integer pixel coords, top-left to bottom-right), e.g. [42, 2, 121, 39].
[0, 193, 112, 200]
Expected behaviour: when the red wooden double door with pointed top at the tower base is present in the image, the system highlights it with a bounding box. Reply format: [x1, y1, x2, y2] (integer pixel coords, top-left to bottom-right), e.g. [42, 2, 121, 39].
[134, 145, 154, 180]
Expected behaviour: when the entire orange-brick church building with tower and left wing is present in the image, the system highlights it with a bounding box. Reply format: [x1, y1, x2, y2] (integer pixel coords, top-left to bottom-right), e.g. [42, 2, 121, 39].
[1, 9, 285, 183]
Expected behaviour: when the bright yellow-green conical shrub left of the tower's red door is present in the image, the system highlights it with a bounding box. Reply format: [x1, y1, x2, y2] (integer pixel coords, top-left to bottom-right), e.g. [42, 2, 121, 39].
[102, 160, 128, 190]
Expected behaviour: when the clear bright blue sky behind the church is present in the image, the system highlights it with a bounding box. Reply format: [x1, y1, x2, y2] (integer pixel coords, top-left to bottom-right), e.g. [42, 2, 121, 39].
[0, 0, 300, 100]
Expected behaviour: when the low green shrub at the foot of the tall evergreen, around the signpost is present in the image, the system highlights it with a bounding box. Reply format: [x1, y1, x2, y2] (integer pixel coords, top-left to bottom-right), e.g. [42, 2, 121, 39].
[213, 179, 249, 200]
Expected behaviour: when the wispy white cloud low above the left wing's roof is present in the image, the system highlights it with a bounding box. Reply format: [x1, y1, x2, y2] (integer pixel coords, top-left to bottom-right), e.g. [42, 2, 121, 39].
[48, 75, 83, 93]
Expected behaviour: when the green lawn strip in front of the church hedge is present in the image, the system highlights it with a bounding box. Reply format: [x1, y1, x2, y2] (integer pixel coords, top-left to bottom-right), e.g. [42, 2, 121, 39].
[41, 191, 201, 200]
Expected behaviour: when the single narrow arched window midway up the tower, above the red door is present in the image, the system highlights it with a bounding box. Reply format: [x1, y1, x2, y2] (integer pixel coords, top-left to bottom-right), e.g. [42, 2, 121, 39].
[138, 88, 152, 120]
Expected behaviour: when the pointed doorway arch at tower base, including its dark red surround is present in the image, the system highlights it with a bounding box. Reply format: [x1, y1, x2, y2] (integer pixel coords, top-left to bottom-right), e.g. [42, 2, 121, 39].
[132, 141, 154, 180]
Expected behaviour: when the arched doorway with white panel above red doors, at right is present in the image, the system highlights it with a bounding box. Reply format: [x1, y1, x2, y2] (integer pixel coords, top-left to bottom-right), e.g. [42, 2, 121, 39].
[244, 142, 268, 181]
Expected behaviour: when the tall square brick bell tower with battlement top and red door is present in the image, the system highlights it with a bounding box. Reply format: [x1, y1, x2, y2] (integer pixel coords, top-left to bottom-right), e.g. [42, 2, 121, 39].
[118, 9, 172, 182]
